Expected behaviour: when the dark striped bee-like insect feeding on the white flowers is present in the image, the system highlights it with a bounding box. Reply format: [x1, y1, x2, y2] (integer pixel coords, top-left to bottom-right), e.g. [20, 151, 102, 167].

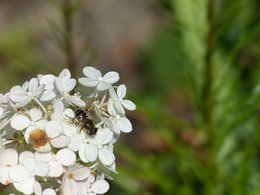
[74, 108, 97, 135]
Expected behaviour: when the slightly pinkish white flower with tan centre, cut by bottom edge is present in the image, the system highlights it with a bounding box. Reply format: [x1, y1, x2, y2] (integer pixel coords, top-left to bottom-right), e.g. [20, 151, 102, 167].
[61, 165, 90, 195]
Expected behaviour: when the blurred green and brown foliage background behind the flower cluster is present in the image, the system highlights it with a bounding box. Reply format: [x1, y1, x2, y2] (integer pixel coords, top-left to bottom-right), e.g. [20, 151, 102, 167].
[0, 0, 260, 195]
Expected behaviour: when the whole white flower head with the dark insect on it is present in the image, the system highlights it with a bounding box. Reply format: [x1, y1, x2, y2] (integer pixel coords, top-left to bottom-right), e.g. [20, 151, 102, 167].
[0, 67, 136, 195]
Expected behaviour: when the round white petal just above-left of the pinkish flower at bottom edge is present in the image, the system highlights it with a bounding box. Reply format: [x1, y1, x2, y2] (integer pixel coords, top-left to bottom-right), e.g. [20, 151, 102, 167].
[55, 148, 76, 166]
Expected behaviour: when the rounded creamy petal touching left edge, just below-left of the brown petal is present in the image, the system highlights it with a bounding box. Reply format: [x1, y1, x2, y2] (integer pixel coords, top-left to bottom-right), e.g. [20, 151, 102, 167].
[0, 149, 18, 166]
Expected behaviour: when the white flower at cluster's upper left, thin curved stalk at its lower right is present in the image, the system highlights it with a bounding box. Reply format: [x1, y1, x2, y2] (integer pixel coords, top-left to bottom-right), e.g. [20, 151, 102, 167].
[9, 78, 44, 107]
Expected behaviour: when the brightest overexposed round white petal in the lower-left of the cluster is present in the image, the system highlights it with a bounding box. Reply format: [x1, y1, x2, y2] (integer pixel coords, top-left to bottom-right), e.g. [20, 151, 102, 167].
[9, 165, 29, 182]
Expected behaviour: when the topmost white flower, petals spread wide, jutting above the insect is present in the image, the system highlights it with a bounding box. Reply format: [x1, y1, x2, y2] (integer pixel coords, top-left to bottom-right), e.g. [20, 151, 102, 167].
[79, 66, 119, 91]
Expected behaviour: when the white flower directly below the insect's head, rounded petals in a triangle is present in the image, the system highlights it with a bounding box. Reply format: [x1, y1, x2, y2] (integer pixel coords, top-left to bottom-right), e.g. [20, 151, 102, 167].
[79, 128, 115, 166]
